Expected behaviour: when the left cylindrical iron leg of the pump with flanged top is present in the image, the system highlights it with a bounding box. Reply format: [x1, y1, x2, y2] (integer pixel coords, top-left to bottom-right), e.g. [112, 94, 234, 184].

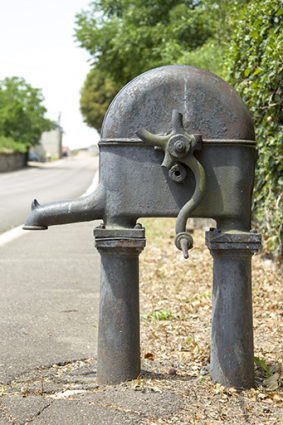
[94, 228, 145, 384]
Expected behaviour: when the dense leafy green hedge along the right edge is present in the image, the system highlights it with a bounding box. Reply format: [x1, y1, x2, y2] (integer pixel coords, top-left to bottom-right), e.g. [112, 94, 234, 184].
[225, 0, 283, 255]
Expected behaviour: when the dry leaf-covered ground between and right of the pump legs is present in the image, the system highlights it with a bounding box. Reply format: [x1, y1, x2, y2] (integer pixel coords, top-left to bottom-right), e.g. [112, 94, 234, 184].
[134, 219, 283, 425]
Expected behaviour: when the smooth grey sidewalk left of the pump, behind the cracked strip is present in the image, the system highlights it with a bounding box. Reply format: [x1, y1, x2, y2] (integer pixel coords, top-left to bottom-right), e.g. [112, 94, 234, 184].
[0, 222, 100, 384]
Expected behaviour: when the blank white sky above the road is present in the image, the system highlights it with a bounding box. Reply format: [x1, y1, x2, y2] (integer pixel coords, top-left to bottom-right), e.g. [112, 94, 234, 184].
[0, 0, 99, 149]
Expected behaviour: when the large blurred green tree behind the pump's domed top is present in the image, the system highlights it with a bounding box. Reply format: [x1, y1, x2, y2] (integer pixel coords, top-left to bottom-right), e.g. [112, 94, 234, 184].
[75, 0, 233, 131]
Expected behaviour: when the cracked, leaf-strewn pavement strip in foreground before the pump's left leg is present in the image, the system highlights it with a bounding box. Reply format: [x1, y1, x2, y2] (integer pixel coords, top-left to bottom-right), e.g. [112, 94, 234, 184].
[0, 358, 184, 425]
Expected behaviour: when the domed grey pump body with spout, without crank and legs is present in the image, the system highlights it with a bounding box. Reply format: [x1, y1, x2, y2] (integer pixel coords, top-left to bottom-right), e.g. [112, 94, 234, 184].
[24, 66, 255, 232]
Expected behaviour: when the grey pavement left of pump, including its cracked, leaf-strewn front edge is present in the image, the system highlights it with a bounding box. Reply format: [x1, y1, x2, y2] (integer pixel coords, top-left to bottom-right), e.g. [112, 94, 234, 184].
[0, 222, 182, 425]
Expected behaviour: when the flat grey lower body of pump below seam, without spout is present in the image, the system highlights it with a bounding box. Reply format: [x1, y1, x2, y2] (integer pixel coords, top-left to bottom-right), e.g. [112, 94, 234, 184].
[95, 141, 255, 231]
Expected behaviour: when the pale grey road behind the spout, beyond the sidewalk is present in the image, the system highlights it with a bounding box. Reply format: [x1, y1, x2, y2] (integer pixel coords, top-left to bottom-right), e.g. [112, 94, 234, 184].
[0, 154, 98, 234]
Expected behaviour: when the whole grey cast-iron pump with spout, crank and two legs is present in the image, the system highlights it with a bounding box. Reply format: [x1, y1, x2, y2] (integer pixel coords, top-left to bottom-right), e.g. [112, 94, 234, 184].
[24, 66, 261, 388]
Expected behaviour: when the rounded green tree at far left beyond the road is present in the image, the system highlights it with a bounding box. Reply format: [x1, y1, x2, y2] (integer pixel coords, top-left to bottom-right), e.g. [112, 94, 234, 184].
[0, 77, 55, 152]
